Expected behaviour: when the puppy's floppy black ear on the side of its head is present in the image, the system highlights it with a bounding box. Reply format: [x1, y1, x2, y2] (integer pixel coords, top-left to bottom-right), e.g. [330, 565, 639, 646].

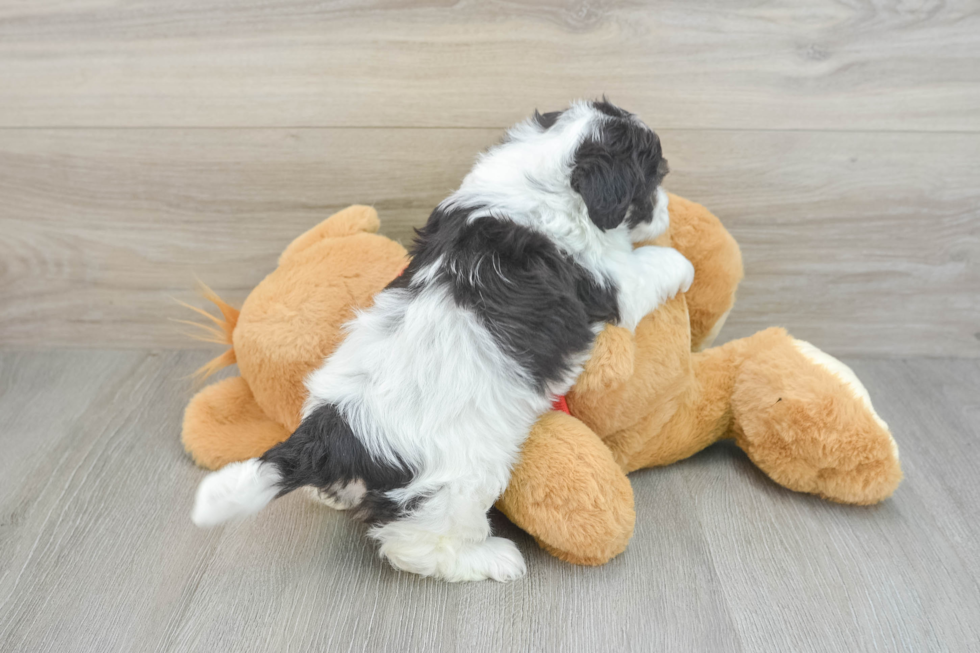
[571, 140, 644, 231]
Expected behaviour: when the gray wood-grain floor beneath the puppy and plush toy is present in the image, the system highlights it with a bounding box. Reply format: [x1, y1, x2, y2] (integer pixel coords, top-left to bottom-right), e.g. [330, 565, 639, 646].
[0, 350, 980, 652]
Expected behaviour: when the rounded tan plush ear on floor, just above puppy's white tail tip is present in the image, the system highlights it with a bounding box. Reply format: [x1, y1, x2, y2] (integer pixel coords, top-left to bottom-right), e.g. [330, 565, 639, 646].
[181, 376, 289, 469]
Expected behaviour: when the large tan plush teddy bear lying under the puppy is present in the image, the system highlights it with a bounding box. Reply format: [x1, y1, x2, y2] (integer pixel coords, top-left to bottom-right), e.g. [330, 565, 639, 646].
[183, 195, 902, 565]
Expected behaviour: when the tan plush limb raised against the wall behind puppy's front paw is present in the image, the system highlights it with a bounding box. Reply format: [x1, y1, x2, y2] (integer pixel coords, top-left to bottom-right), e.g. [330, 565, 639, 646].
[669, 195, 743, 351]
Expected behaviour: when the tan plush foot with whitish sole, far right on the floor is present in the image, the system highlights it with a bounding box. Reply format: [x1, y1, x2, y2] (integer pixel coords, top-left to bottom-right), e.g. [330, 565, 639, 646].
[732, 329, 902, 504]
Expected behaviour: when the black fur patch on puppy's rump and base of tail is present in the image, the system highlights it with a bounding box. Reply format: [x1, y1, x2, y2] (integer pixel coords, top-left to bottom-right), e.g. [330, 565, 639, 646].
[261, 404, 413, 524]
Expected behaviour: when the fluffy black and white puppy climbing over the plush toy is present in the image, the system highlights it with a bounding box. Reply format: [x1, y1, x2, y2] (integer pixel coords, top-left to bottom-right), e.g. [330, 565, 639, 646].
[192, 101, 694, 581]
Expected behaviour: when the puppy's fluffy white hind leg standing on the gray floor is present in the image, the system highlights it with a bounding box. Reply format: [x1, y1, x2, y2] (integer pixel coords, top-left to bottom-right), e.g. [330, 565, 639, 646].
[371, 487, 527, 582]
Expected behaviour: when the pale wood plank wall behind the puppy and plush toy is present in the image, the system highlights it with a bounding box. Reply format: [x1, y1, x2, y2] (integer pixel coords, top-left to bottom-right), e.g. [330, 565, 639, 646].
[0, 0, 980, 357]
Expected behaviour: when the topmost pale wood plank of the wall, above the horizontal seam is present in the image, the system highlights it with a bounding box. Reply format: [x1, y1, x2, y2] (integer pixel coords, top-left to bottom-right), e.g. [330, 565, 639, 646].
[0, 0, 980, 131]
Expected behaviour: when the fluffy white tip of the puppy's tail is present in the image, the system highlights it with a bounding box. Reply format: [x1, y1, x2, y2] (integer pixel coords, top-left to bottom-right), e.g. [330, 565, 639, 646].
[191, 458, 281, 528]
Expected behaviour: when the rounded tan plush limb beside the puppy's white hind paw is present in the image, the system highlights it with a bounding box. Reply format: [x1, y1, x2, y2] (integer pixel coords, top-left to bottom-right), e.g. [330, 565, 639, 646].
[497, 412, 636, 565]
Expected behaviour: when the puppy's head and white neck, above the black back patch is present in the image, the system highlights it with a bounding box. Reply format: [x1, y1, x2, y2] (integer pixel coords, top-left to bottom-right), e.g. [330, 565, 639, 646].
[450, 100, 667, 242]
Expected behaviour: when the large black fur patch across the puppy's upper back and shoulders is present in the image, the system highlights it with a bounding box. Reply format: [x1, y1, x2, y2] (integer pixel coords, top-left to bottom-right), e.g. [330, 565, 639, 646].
[396, 209, 619, 391]
